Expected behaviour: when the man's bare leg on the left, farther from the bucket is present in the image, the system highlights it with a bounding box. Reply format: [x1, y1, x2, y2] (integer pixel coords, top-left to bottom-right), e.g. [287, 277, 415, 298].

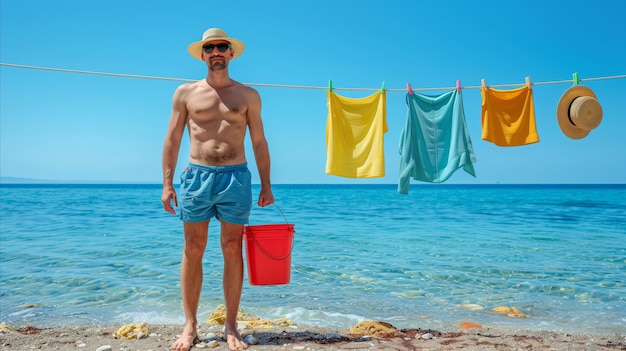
[171, 221, 209, 351]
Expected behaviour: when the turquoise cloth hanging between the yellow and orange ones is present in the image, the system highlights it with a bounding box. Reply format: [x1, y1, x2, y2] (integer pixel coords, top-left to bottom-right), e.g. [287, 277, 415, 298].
[398, 90, 476, 194]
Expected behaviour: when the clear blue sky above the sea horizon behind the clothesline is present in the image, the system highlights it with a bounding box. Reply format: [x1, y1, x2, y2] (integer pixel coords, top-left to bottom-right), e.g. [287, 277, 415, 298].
[0, 0, 626, 184]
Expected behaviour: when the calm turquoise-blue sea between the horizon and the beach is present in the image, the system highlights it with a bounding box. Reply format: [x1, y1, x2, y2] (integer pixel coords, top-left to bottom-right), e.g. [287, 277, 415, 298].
[0, 184, 626, 333]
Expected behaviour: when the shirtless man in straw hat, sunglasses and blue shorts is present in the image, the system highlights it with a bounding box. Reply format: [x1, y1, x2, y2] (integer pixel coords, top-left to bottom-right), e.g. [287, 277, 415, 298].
[161, 28, 274, 351]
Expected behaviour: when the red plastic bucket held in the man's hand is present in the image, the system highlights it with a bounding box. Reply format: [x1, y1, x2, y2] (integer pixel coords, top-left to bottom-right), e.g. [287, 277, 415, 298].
[243, 206, 295, 285]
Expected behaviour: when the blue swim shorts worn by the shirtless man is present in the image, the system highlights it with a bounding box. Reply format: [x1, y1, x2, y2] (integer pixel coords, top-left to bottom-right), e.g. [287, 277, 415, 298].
[178, 163, 252, 224]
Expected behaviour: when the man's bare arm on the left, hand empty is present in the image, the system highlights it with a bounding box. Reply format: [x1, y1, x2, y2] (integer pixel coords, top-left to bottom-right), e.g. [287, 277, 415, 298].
[161, 85, 188, 214]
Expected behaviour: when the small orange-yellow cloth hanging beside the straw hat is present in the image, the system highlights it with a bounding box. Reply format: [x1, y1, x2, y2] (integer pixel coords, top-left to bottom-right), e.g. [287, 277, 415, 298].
[480, 86, 539, 146]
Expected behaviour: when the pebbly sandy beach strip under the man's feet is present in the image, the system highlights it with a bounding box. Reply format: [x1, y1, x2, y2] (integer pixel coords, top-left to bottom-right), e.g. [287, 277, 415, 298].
[0, 323, 626, 351]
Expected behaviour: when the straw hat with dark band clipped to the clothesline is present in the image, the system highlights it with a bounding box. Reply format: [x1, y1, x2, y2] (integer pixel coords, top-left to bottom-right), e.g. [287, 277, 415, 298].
[556, 85, 602, 139]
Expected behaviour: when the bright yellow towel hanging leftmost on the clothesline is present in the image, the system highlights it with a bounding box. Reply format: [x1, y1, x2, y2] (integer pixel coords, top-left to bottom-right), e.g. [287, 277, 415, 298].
[326, 91, 387, 178]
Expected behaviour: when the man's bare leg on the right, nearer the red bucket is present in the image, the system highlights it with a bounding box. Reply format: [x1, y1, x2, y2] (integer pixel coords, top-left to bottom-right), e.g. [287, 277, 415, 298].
[221, 221, 248, 350]
